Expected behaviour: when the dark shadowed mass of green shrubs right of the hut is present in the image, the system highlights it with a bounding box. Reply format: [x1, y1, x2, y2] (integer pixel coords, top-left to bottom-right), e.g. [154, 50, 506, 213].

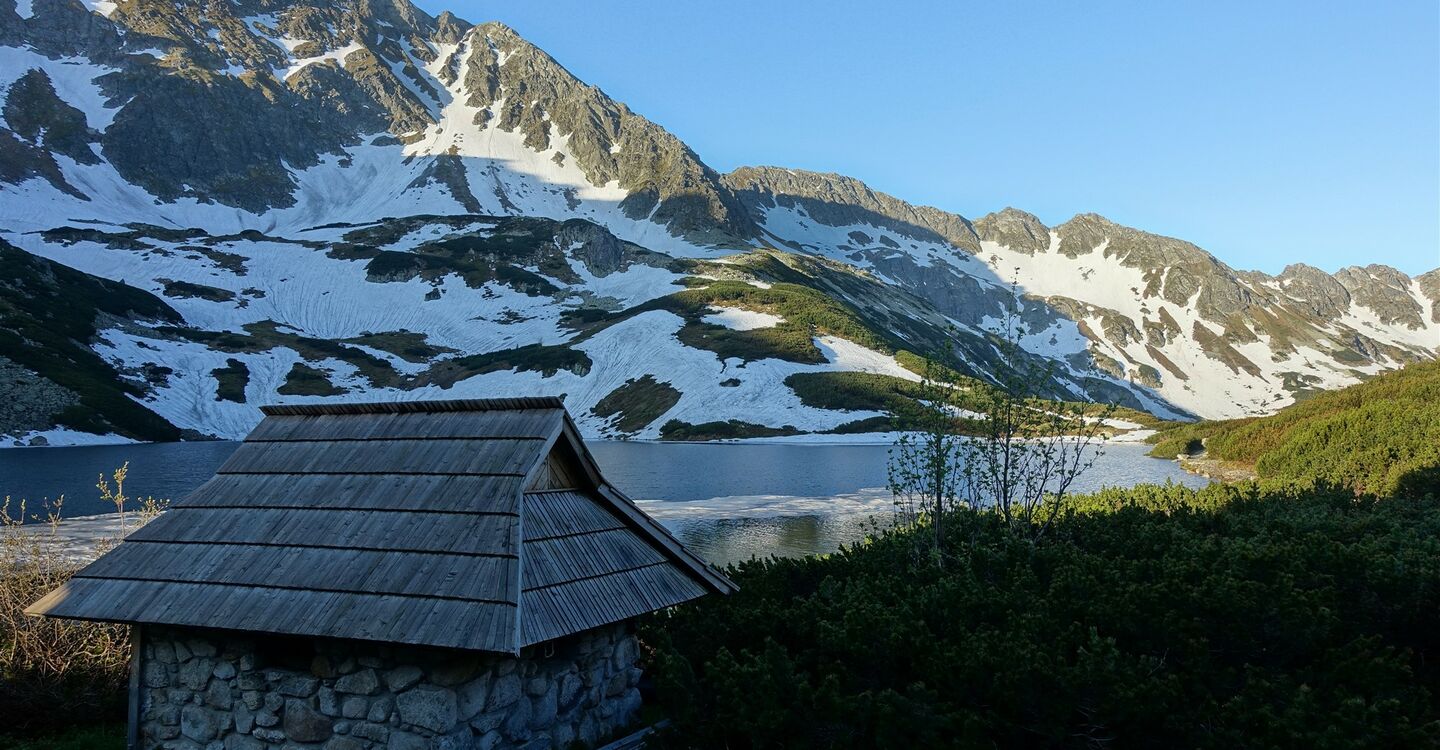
[644, 482, 1440, 749]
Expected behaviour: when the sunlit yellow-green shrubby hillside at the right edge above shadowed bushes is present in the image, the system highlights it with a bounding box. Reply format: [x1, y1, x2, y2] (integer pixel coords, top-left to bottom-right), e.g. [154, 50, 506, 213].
[1151, 361, 1440, 495]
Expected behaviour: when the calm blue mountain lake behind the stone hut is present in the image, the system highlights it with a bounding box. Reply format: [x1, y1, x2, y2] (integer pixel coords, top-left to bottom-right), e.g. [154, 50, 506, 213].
[0, 440, 1208, 564]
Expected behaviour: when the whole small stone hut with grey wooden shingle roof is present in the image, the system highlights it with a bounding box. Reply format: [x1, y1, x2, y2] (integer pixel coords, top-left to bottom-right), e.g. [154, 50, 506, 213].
[29, 397, 734, 750]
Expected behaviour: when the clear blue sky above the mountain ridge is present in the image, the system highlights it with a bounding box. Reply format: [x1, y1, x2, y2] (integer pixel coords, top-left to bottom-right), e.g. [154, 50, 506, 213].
[419, 0, 1440, 274]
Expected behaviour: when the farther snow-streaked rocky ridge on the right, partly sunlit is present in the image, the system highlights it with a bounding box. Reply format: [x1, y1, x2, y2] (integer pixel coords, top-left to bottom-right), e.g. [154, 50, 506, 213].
[726, 168, 1440, 419]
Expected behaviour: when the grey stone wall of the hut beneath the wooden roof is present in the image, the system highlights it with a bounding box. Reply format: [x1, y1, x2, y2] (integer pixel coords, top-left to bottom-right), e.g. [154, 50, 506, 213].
[140, 623, 641, 750]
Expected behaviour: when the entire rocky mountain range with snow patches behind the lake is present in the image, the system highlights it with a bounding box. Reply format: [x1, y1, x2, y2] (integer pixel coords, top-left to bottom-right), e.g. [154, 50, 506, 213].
[0, 0, 1440, 445]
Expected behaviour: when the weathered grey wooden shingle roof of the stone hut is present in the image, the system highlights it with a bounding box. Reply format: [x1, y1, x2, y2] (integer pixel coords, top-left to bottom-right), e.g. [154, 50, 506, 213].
[27, 397, 734, 654]
